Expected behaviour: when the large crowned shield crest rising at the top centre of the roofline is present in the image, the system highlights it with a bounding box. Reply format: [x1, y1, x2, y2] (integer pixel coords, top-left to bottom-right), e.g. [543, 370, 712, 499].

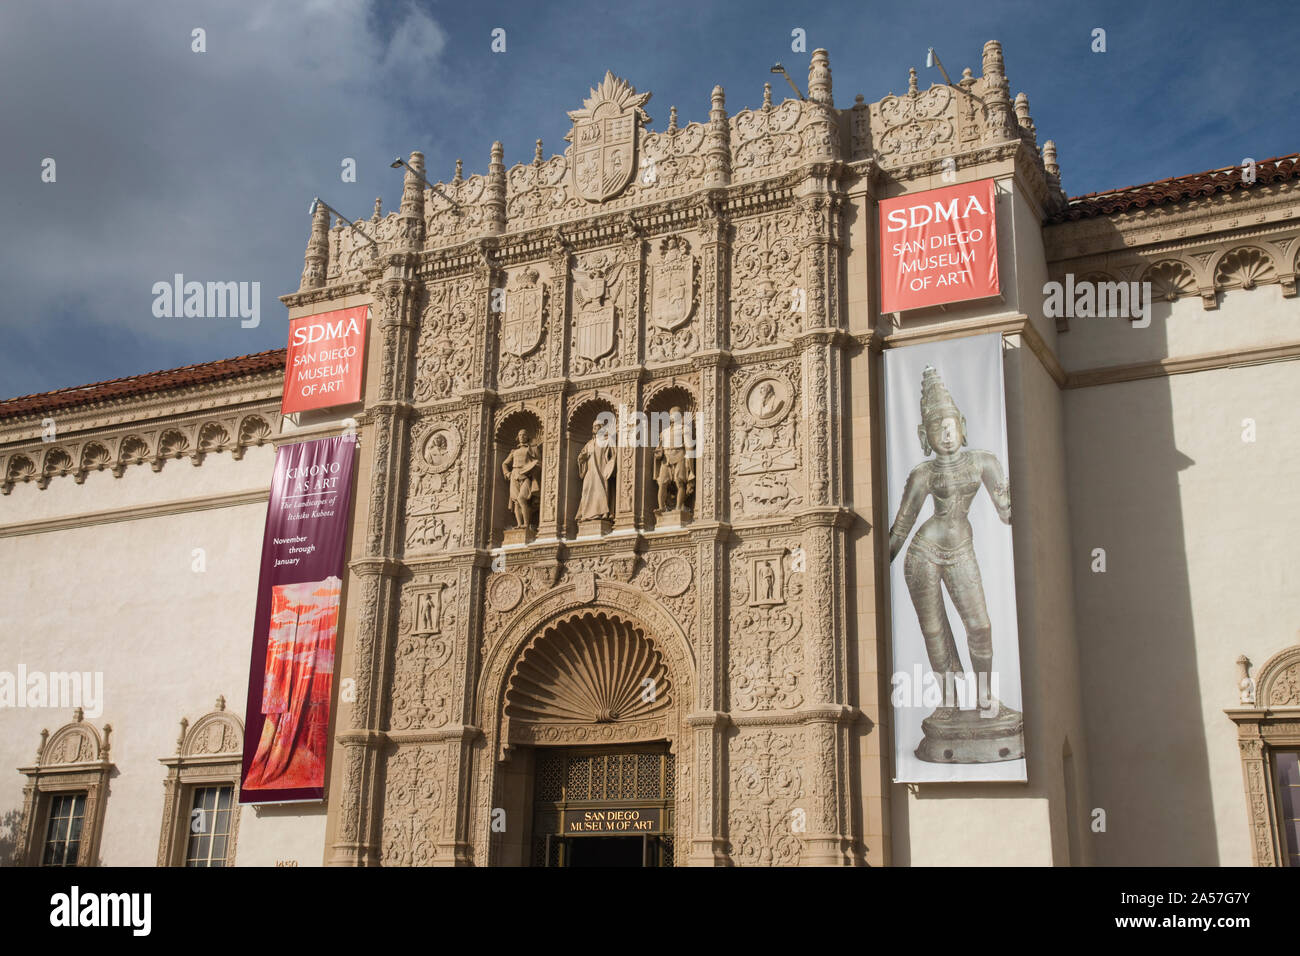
[566, 70, 650, 203]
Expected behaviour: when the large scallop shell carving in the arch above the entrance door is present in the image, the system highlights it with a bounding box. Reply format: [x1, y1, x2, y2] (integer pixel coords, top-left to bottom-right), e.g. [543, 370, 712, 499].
[506, 611, 672, 723]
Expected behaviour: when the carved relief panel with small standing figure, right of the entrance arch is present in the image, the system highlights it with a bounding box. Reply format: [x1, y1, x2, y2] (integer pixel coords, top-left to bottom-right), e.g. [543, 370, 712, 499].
[728, 542, 807, 713]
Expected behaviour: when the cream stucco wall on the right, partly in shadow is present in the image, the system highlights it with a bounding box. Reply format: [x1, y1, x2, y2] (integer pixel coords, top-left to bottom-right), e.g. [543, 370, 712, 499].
[1062, 285, 1300, 865]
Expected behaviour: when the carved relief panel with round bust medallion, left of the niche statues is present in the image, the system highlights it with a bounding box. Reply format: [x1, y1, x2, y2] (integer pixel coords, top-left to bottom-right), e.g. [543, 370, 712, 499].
[406, 414, 467, 554]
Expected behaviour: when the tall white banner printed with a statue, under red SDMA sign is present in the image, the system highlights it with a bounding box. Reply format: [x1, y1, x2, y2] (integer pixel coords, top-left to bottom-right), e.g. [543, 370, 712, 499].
[885, 334, 1027, 783]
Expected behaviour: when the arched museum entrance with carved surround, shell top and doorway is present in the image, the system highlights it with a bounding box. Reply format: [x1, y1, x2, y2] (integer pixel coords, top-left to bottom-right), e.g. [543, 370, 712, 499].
[476, 575, 693, 866]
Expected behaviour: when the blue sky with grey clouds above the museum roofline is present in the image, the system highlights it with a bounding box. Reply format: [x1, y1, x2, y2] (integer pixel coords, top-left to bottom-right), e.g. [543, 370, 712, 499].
[0, 0, 1300, 397]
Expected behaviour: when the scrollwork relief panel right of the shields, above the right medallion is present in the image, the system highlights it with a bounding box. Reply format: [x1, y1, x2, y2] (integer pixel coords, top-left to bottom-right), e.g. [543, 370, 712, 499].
[731, 209, 807, 350]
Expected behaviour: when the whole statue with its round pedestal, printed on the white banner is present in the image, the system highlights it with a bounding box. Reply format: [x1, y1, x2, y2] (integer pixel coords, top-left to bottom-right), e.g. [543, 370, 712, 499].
[889, 365, 1024, 763]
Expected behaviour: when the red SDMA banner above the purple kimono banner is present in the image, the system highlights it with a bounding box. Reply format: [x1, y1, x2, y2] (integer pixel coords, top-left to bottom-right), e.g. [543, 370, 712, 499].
[280, 306, 369, 415]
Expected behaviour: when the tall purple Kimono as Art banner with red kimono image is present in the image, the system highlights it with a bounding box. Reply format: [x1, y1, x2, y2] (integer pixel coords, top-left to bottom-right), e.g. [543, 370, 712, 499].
[239, 436, 356, 804]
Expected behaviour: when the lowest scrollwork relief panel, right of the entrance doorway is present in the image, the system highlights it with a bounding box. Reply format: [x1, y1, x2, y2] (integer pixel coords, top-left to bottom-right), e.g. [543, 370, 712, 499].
[728, 728, 805, 866]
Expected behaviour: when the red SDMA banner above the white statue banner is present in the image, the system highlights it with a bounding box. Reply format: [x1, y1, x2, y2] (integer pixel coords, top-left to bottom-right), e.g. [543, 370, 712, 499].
[880, 179, 1000, 312]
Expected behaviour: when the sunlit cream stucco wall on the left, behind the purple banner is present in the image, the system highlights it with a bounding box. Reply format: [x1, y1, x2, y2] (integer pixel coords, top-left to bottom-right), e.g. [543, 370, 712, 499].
[0, 444, 325, 866]
